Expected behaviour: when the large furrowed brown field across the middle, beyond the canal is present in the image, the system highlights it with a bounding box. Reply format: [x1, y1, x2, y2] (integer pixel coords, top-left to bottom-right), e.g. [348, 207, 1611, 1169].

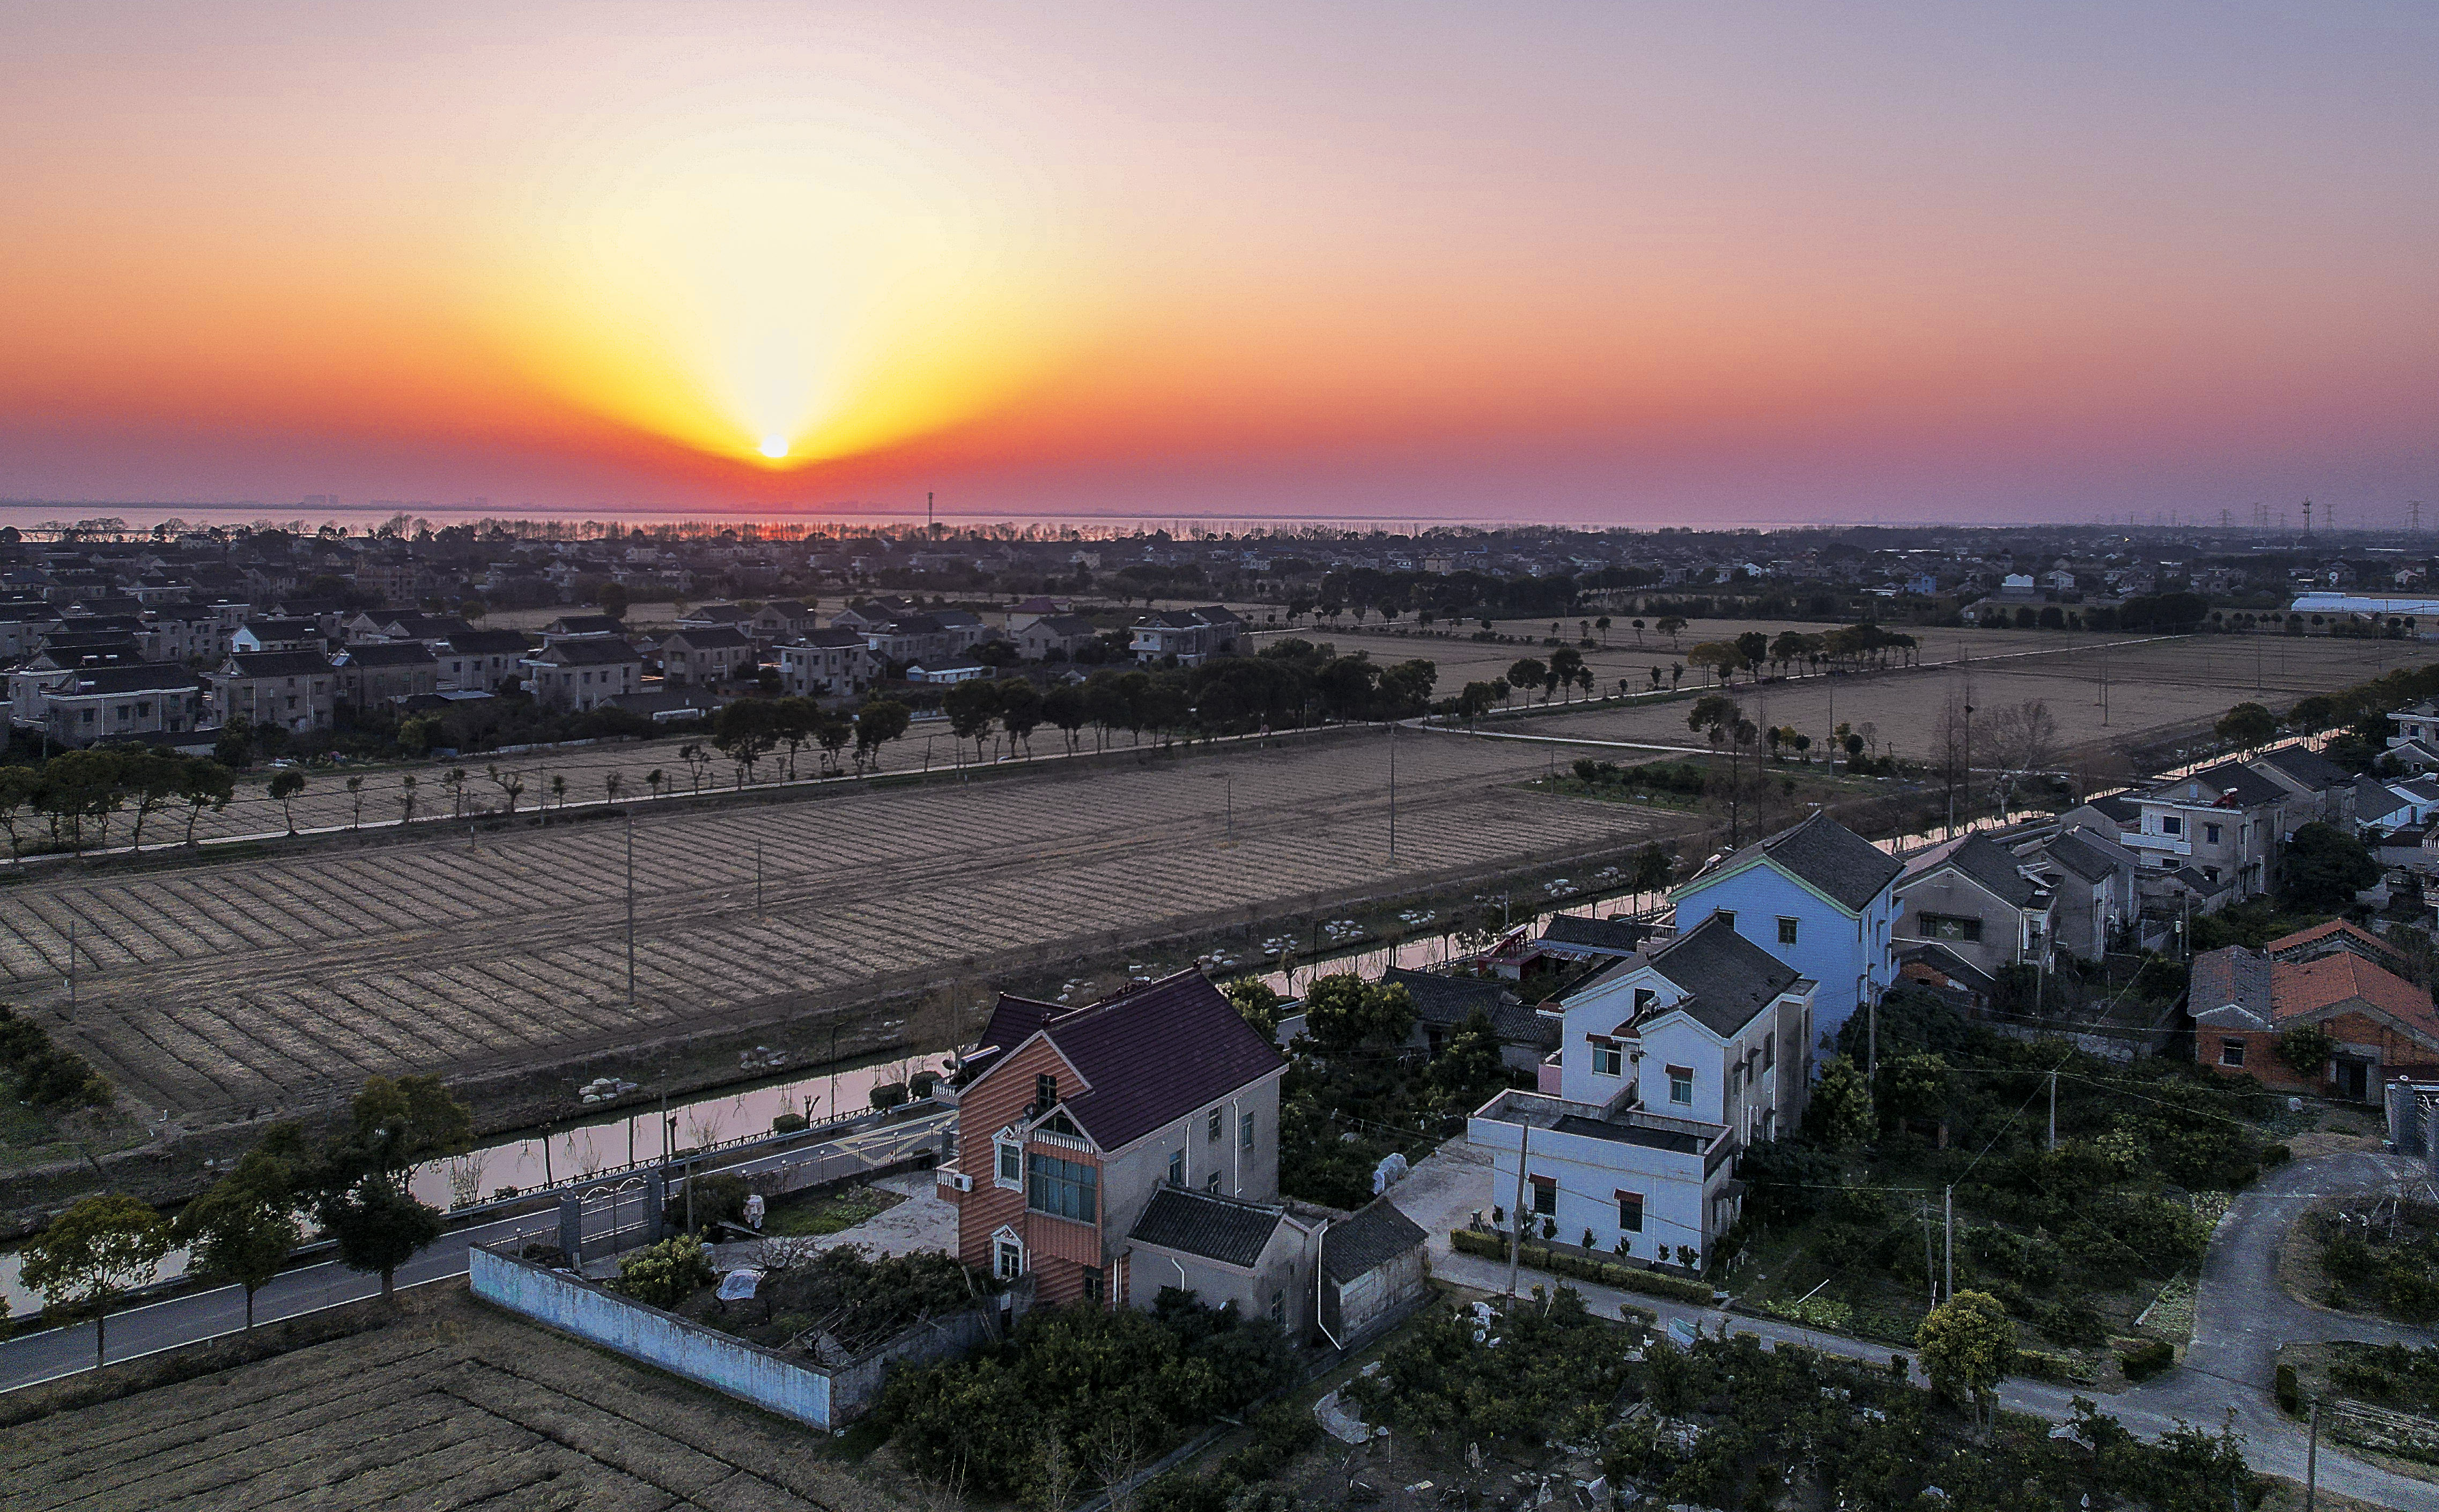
[0, 732, 1690, 1117]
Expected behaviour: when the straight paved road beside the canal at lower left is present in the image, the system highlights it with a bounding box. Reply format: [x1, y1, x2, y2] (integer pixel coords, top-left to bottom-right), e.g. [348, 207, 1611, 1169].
[0, 1110, 956, 1390]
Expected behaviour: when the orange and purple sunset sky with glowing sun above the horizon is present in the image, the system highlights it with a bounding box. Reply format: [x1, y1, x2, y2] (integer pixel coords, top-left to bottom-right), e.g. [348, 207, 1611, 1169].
[0, 0, 2439, 524]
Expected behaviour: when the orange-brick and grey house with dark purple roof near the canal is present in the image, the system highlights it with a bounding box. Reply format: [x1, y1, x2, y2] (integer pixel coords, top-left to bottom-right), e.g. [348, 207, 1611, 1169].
[939, 970, 1319, 1326]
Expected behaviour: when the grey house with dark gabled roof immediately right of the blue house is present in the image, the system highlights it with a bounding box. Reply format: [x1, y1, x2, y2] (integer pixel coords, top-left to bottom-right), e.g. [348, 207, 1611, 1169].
[1895, 834, 2056, 1002]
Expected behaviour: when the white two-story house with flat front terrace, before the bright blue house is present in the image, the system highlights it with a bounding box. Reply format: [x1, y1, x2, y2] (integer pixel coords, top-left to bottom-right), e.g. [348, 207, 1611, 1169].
[1468, 915, 1817, 1261]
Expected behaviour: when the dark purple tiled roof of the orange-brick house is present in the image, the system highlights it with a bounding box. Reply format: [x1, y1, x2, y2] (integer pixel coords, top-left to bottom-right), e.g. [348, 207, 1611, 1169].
[1063, 970, 1285, 1151]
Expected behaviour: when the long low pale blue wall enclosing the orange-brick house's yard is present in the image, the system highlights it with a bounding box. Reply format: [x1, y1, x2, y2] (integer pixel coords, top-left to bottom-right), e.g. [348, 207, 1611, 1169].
[466, 1244, 997, 1429]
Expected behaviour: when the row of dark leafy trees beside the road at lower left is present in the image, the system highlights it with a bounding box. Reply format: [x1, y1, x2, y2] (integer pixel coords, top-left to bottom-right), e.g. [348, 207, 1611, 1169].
[24, 1076, 473, 1366]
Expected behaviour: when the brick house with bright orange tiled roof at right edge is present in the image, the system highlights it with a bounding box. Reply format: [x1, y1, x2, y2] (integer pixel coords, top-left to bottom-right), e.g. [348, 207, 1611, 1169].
[2185, 922, 2439, 1102]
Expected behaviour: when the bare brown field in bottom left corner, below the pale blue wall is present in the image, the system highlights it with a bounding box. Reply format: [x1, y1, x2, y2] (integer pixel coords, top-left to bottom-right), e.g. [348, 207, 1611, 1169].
[0, 1283, 900, 1512]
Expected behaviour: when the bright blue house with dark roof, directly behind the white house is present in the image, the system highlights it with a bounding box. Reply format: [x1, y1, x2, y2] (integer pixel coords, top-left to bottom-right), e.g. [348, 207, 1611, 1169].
[1671, 812, 1905, 1039]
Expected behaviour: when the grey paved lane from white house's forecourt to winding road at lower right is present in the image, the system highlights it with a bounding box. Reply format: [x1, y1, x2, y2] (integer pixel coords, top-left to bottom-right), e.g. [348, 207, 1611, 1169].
[1390, 1142, 2439, 1512]
